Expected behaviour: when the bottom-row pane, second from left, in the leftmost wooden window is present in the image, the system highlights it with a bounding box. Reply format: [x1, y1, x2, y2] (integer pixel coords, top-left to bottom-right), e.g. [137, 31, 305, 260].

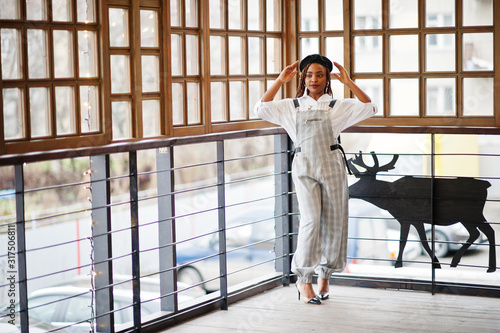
[29, 87, 50, 138]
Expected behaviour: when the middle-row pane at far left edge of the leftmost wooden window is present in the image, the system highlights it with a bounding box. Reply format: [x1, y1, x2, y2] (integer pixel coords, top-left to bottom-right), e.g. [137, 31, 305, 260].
[0, 29, 23, 80]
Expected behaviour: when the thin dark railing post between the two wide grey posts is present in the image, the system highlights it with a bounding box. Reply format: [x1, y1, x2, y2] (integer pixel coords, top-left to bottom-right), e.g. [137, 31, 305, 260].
[129, 151, 141, 331]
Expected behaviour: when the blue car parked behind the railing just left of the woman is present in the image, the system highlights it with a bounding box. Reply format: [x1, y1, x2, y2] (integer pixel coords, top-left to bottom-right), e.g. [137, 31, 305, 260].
[177, 207, 276, 293]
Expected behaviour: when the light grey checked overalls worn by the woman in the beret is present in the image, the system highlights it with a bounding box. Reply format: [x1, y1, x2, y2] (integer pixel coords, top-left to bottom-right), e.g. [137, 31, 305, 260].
[292, 99, 349, 283]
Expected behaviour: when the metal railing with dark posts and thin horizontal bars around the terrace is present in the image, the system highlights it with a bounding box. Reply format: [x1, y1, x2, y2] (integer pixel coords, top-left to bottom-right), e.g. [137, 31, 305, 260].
[0, 129, 500, 332]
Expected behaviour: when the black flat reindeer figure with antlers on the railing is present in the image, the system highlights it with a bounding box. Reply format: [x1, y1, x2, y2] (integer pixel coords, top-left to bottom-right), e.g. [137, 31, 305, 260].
[348, 152, 496, 273]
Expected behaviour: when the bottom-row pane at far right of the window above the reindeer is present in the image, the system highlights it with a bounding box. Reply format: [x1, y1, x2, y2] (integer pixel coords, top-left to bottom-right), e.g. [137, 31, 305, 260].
[463, 77, 494, 116]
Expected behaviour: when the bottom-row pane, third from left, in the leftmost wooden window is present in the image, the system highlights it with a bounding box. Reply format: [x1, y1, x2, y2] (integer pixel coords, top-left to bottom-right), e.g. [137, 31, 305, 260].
[55, 87, 76, 135]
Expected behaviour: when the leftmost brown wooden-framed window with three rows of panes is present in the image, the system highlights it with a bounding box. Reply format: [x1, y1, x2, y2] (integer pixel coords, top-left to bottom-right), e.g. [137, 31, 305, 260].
[0, 0, 103, 151]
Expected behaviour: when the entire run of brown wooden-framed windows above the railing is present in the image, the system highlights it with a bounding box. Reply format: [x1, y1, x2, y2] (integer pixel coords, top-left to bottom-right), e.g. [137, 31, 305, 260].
[0, 0, 500, 154]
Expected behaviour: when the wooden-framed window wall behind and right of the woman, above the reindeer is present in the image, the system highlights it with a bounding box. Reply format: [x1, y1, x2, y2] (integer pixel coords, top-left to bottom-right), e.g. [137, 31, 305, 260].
[298, 0, 500, 126]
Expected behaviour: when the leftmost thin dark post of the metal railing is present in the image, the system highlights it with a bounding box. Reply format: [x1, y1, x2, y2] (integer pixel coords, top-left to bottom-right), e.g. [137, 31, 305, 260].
[14, 164, 29, 332]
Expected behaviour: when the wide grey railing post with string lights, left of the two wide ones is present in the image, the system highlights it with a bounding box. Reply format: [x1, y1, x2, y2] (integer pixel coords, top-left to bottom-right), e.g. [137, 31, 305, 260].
[90, 154, 115, 332]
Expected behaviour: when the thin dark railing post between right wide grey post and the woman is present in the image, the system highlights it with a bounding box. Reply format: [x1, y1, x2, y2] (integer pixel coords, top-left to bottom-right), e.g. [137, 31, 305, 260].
[217, 141, 228, 310]
